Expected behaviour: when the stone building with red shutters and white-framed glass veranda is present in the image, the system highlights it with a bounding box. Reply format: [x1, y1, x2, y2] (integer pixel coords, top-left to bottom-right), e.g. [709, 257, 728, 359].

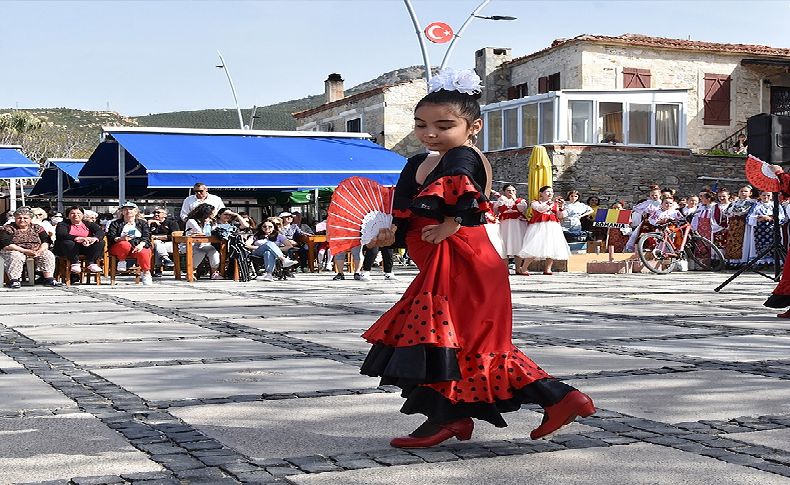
[475, 34, 790, 151]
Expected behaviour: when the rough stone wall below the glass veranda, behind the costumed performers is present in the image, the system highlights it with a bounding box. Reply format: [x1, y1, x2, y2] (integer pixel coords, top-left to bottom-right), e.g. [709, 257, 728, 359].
[487, 145, 746, 205]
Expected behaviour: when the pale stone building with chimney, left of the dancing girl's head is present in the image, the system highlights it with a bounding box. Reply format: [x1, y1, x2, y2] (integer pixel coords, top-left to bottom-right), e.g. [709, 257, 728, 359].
[293, 74, 426, 157]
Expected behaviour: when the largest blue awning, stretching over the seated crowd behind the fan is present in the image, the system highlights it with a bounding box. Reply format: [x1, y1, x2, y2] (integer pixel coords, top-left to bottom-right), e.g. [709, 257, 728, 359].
[79, 128, 406, 189]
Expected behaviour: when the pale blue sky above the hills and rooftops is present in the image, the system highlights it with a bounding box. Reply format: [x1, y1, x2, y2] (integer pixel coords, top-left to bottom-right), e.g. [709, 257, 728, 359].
[0, 0, 790, 116]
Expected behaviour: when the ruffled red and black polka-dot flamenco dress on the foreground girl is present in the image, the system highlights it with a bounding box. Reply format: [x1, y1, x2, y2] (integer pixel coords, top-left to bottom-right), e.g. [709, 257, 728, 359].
[361, 147, 574, 427]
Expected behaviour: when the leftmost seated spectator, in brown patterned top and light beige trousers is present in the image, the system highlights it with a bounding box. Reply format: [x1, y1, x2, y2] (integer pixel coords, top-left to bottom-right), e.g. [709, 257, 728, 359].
[0, 207, 60, 288]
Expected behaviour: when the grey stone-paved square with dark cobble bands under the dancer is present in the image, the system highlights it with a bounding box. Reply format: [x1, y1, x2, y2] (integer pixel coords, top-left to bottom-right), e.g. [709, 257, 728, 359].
[0, 269, 790, 485]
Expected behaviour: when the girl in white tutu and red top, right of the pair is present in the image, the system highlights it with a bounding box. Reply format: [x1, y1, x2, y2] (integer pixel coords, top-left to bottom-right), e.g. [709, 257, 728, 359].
[518, 186, 571, 275]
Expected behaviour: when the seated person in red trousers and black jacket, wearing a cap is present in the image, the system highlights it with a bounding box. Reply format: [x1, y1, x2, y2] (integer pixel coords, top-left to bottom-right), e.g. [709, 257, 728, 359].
[107, 202, 153, 285]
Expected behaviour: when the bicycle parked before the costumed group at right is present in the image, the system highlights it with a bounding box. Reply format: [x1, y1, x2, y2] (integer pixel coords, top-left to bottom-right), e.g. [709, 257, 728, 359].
[637, 220, 725, 274]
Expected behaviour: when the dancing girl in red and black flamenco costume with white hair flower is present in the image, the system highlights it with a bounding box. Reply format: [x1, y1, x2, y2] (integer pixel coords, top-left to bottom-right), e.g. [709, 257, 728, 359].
[361, 70, 595, 448]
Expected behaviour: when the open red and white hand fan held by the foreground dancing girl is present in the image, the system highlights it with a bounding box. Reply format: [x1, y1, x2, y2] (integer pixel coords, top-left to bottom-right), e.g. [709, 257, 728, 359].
[326, 177, 394, 254]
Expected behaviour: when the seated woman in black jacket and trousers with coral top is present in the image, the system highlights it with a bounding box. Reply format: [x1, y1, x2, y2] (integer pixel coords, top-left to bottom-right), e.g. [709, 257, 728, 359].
[53, 205, 104, 282]
